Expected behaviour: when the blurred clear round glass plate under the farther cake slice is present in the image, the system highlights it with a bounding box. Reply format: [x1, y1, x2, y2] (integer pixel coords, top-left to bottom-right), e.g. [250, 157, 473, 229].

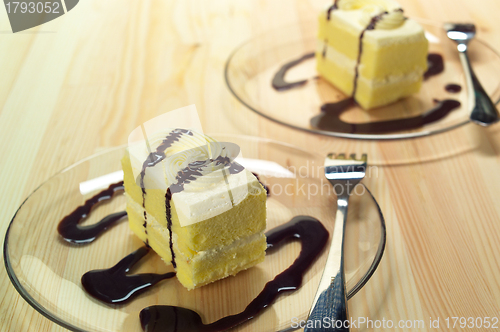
[225, 20, 500, 139]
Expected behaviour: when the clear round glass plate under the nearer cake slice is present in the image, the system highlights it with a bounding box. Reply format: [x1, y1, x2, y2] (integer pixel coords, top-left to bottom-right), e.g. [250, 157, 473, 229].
[4, 135, 385, 332]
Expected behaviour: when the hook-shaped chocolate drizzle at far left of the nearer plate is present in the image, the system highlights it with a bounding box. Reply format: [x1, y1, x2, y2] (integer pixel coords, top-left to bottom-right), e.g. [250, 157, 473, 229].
[57, 181, 127, 244]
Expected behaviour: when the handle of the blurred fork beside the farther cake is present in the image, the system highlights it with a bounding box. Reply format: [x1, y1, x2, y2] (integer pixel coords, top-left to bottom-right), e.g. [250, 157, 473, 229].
[458, 49, 499, 126]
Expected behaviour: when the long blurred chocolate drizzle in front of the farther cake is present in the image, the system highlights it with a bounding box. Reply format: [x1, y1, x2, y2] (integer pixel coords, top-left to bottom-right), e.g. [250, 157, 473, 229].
[311, 98, 460, 134]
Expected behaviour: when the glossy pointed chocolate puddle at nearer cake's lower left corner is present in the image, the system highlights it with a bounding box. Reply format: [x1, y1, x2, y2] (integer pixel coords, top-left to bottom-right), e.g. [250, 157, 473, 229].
[82, 247, 175, 304]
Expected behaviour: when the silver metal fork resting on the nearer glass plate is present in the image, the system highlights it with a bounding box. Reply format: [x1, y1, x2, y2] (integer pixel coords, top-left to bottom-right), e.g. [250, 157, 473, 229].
[304, 153, 368, 332]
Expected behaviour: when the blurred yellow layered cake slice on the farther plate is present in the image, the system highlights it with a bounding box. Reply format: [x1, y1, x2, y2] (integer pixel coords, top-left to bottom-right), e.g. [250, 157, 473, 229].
[316, 0, 428, 109]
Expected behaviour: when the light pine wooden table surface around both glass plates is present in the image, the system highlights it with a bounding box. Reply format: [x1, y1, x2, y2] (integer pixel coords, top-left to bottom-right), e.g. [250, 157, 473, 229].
[0, 0, 500, 332]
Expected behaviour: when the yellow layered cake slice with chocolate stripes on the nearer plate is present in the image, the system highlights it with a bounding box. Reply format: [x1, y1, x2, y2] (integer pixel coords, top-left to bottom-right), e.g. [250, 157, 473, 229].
[122, 129, 267, 289]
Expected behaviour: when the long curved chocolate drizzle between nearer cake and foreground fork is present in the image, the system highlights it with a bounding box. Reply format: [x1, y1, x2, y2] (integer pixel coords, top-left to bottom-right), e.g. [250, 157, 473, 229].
[139, 216, 328, 332]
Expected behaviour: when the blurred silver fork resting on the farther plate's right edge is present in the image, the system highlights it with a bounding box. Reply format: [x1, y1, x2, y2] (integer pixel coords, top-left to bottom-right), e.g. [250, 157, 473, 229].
[444, 23, 499, 126]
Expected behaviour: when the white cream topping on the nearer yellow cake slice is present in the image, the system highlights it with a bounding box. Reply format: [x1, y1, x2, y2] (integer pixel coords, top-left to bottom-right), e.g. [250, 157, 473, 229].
[129, 130, 260, 226]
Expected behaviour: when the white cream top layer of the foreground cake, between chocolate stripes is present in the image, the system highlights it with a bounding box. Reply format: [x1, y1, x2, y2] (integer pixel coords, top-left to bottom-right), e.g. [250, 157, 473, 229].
[129, 131, 262, 226]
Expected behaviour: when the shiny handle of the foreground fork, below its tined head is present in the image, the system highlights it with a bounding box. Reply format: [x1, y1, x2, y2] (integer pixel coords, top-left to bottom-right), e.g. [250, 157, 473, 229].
[304, 193, 349, 332]
